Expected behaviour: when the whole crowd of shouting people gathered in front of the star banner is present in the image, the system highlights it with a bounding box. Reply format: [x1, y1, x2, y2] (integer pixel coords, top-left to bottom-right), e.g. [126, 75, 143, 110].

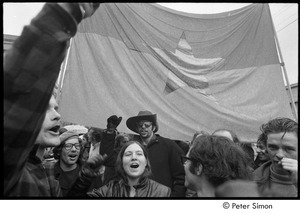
[3, 3, 298, 198]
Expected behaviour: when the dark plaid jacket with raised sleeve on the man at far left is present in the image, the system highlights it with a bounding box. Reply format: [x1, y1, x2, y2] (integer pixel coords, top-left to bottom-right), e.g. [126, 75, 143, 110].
[4, 3, 81, 196]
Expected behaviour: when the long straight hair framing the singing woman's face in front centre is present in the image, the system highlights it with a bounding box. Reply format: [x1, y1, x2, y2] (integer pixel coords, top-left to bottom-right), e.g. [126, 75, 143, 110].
[116, 141, 151, 180]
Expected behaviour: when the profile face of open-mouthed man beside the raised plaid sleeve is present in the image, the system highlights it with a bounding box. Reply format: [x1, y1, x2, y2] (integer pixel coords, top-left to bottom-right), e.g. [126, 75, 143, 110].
[36, 96, 61, 147]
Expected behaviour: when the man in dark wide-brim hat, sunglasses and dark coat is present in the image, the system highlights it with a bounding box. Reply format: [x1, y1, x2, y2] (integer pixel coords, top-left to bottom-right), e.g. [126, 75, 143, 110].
[126, 111, 186, 197]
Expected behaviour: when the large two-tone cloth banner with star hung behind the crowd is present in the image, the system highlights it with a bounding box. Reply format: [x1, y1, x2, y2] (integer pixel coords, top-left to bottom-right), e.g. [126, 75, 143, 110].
[59, 3, 293, 142]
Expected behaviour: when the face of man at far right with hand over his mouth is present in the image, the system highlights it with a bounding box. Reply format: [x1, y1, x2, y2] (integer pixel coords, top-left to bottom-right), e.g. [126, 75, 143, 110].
[267, 132, 298, 167]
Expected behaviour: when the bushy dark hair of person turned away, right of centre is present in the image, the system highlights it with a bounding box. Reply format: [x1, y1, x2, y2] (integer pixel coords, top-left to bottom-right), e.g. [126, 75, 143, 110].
[189, 135, 252, 187]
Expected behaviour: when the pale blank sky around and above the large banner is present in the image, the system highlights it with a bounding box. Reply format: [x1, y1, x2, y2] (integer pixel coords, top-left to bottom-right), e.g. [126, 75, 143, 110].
[3, 2, 298, 84]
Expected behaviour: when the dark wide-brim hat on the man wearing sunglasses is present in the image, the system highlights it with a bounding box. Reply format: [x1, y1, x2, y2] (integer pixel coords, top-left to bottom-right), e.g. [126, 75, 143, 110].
[126, 110, 158, 133]
